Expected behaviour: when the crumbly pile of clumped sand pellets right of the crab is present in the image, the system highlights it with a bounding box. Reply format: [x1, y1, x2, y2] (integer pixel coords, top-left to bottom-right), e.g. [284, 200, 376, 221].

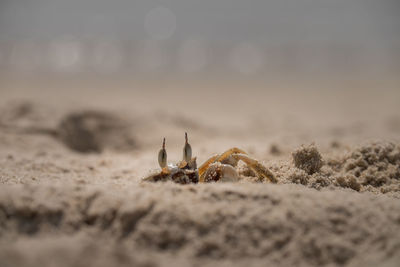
[274, 142, 400, 197]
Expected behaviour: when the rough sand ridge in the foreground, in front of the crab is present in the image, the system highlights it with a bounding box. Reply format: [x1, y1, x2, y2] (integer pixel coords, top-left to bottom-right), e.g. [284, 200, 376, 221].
[0, 183, 400, 266]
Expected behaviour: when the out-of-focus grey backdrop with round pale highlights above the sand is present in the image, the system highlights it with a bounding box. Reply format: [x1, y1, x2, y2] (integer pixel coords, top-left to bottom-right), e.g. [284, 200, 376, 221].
[0, 0, 400, 77]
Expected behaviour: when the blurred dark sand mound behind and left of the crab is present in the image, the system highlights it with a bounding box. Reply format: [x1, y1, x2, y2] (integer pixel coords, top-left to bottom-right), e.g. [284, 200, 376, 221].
[0, 101, 138, 153]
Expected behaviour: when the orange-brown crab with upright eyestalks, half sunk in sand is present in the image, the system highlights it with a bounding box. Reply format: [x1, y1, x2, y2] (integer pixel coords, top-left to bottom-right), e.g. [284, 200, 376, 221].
[143, 133, 277, 184]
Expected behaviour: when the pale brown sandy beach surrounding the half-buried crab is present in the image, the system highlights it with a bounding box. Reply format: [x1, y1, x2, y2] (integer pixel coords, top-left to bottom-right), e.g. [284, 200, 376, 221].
[0, 78, 400, 266]
